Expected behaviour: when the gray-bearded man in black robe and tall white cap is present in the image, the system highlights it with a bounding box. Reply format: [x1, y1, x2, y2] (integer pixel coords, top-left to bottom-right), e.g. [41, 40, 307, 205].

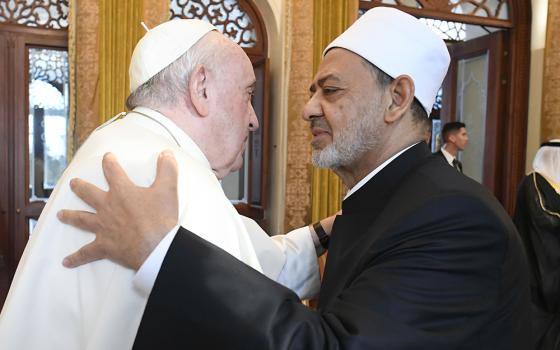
[61, 7, 530, 350]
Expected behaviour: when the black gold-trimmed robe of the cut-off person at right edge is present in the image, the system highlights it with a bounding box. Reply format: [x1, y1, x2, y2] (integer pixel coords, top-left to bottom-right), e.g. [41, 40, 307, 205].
[514, 173, 560, 350]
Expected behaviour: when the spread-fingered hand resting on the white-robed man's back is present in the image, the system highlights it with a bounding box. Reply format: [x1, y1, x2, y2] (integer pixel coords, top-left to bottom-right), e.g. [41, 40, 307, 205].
[58, 151, 178, 270]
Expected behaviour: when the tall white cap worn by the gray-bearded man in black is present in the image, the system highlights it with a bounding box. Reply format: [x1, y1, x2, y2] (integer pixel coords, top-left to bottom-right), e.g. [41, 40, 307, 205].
[323, 7, 450, 115]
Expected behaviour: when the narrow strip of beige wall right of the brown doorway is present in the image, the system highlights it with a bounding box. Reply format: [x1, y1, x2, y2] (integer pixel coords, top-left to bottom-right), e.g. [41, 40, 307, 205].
[525, 0, 548, 172]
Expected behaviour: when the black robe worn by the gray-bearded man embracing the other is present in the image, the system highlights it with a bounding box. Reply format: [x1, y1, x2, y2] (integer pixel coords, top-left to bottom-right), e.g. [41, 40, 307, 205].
[134, 143, 531, 350]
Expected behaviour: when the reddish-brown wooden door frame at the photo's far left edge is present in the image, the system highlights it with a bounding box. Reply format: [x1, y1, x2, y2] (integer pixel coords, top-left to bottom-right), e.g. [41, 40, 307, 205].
[0, 24, 68, 275]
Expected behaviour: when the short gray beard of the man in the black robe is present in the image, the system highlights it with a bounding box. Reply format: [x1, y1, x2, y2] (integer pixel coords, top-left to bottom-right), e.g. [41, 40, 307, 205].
[312, 113, 381, 169]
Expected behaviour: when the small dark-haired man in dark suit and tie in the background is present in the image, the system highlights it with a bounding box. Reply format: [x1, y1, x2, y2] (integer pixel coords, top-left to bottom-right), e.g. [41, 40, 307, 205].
[436, 122, 469, 173]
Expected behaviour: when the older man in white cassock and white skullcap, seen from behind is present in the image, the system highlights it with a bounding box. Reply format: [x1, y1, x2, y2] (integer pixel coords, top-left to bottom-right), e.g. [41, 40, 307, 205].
[0, 20, 319, 350]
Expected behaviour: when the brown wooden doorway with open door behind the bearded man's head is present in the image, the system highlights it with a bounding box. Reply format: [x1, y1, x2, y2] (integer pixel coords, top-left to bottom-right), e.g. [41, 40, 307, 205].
[360, 0, 531, 213]
